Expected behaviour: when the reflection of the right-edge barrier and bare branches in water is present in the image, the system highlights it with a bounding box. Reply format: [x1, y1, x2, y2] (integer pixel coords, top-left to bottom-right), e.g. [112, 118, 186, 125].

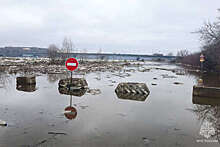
[192, 96, 220, 143]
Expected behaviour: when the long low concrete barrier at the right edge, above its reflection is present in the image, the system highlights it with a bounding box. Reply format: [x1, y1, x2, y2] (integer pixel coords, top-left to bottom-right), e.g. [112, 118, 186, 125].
[193, 86, 220, 99]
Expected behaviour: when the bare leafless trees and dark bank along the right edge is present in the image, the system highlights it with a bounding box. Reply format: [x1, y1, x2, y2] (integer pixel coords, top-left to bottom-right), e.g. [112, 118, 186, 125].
[178, 9, 220, 72]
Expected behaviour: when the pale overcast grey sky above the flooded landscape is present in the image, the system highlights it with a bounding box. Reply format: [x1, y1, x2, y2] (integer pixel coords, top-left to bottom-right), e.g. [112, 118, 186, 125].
[0, 0, 220, 54]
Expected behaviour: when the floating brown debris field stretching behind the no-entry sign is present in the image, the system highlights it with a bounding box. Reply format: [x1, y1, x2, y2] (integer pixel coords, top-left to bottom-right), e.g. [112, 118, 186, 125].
[0, 58, 140, 74]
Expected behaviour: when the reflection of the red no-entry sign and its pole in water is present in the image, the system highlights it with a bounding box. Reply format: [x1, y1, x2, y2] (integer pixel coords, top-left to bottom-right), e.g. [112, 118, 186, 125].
[64, 95, 77, 120]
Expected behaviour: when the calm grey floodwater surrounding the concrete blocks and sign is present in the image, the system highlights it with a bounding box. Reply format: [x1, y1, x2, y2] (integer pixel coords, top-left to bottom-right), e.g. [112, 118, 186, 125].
[0, 62, 220, 147]
